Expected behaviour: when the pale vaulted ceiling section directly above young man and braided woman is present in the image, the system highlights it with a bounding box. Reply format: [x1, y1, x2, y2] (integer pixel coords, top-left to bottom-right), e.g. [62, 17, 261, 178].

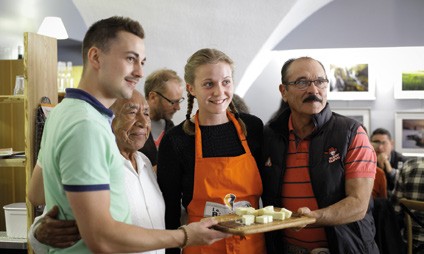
[73, 0, 329, 92]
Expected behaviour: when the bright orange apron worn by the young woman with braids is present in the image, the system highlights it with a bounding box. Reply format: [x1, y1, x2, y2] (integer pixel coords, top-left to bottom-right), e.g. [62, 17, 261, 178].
[183, 112, 266, 254]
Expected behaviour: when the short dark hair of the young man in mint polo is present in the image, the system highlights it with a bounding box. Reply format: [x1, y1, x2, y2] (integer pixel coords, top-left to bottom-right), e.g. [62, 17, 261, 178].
[82, 16, 144, 66]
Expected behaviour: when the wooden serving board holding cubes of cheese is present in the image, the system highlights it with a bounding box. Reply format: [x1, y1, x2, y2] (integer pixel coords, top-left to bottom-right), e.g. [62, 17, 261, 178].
[204, 214, 316, 236]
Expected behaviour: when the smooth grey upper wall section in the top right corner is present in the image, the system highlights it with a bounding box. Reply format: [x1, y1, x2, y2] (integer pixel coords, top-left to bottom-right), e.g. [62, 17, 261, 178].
[274, 0, 424, 50]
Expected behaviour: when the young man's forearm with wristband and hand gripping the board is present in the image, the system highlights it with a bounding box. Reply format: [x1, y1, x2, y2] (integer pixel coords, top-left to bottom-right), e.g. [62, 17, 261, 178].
[75, 209, 230, 253]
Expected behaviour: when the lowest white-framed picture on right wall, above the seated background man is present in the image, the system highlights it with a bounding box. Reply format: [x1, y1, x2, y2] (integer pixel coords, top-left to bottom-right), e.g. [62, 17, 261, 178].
[395, 112, 424, 154]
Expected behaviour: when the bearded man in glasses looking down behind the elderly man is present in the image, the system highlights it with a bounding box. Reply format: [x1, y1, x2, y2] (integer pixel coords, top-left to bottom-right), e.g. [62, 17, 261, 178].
[139, 69, 184, 168]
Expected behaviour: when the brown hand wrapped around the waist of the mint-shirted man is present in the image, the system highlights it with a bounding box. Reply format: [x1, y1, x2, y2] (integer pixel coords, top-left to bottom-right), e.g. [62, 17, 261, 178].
[34, 206, 81, 248]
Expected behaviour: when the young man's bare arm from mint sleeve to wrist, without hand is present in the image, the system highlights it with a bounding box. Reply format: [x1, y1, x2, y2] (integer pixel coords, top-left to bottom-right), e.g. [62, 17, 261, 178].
[67, 191, 184, 253]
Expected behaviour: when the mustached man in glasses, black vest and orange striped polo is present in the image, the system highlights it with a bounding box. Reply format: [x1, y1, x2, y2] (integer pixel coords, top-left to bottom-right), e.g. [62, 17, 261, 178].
[262, 57, 379, 254]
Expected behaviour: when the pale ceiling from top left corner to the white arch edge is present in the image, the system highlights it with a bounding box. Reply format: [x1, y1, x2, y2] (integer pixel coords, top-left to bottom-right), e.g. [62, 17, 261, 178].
[0, 0, 331, 94]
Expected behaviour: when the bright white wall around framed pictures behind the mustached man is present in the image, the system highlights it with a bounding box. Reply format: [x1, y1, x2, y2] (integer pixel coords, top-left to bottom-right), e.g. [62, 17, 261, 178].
[245, 47, 424, 154]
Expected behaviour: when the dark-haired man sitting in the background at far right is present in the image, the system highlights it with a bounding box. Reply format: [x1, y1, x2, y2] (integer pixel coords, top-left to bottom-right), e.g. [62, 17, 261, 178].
[370, 128, 407, 195]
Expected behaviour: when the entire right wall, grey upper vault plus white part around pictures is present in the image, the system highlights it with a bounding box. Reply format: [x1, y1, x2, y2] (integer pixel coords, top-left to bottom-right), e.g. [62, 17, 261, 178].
[244, 0, 424, 157]
